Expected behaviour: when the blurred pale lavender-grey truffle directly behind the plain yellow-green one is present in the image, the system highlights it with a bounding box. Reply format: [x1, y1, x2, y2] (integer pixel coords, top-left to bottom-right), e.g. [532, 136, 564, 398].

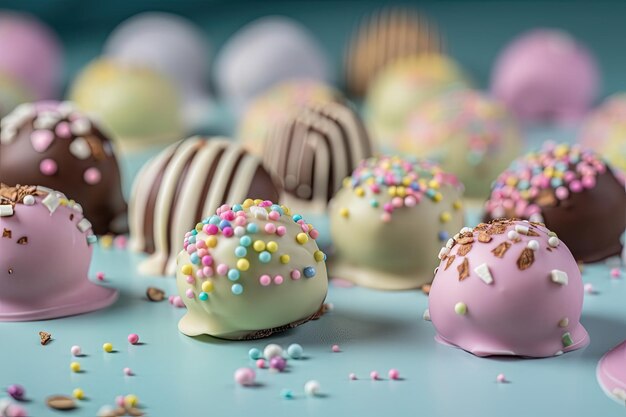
[104, 12, 212, 130]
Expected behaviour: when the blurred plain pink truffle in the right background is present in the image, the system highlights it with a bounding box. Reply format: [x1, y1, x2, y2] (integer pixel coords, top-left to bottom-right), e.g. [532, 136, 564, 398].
[491, 29, 600, 122]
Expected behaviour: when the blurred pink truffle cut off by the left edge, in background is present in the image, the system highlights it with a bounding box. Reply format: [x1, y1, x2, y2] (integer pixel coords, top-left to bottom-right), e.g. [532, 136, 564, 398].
[0, 11, 63, 100]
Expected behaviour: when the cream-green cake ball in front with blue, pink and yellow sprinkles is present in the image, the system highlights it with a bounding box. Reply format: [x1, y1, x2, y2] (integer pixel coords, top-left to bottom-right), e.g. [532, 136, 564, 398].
[176, 199, 328, 339]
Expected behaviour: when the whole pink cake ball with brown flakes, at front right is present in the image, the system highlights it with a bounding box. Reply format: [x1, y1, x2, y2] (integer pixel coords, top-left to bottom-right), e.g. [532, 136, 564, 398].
[428, 220, 589, 358]
